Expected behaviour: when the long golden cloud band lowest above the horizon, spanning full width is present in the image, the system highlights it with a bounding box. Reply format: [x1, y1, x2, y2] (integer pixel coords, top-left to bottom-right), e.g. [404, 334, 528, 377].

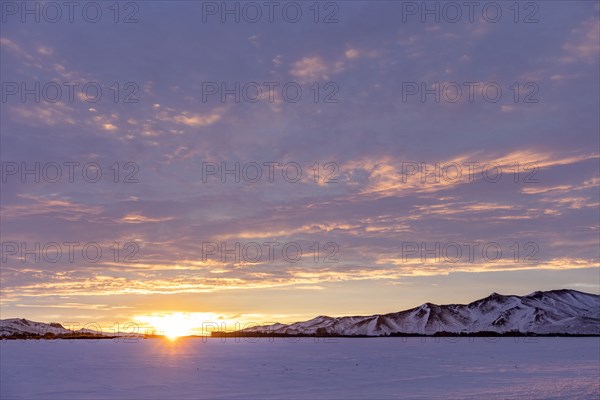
[3, 256, 598, 303]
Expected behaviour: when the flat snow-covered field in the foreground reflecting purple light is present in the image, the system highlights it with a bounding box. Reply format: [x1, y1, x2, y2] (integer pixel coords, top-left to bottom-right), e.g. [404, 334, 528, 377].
[0, 338, 600, 400]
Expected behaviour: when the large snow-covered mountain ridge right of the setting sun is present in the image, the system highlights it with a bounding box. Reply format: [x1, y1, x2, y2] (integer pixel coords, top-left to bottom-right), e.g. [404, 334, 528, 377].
[239, 289, 600, 336]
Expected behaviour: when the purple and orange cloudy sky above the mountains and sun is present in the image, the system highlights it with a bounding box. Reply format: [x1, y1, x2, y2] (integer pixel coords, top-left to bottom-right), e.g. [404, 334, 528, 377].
[0, 1, 600, 330]
